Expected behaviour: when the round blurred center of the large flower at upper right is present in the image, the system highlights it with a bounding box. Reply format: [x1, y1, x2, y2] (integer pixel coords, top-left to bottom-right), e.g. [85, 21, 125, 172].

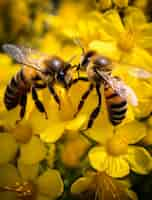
[117, 30, 135, 52]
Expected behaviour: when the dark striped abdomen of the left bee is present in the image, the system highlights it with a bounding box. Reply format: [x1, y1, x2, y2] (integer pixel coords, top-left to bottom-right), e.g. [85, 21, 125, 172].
[4, 69, 28, 110]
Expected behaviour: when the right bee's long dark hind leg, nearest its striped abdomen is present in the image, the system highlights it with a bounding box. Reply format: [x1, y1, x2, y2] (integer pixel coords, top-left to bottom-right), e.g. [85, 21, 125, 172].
[86, 85, 102, 130]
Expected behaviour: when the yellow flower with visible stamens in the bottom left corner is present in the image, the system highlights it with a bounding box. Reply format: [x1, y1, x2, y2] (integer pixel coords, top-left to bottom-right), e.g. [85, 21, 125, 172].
[0, 163, 63, 200]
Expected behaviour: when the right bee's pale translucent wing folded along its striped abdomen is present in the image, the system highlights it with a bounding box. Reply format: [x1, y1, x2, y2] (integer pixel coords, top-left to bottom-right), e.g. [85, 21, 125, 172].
[96, 70, 138, 106]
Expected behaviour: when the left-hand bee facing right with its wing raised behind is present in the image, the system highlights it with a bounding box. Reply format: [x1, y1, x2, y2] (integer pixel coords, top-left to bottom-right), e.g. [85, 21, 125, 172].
[2, 44, 71, 123]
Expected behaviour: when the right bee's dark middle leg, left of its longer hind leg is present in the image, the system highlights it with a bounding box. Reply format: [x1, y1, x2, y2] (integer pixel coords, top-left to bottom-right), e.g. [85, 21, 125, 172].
[74, 84, 94, 117]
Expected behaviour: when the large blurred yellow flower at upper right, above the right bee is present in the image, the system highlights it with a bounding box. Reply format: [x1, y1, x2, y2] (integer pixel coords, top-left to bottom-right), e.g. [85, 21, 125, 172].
[89, 8, 152, 69]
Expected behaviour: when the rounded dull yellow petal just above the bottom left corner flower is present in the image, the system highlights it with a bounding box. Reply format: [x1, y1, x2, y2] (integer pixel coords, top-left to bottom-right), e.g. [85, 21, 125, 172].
[20, 136, 46, 165]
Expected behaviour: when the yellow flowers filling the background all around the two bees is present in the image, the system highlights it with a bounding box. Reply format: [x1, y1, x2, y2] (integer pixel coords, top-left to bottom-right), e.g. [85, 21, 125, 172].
[0, 0, 152, 200]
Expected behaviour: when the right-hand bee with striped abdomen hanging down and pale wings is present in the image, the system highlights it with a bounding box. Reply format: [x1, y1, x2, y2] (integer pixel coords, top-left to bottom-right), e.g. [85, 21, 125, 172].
[71, 46, 152, 130]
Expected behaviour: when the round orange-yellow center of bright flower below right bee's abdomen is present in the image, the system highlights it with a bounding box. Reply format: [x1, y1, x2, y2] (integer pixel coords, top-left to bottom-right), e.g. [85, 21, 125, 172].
[106, 136, 128, 156]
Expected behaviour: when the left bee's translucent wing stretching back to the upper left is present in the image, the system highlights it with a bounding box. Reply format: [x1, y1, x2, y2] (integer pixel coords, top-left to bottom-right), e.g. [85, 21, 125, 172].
[2, 44, 45, 71]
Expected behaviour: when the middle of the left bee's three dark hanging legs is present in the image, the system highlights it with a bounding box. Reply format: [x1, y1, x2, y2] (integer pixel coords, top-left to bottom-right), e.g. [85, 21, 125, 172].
[32, 87, 48, 119]
